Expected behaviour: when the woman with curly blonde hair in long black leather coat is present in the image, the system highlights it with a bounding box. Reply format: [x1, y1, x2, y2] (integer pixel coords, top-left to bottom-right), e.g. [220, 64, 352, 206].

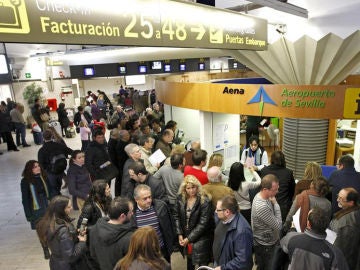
[174, 175, 214, 270]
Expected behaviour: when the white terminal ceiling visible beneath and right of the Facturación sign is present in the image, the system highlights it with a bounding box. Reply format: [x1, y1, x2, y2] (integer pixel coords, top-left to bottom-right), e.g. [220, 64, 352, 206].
[5, 0, 360, 70]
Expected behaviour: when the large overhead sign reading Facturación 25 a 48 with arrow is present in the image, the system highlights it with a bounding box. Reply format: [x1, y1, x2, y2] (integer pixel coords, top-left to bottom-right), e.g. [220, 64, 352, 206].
[0, 0, 267, 50]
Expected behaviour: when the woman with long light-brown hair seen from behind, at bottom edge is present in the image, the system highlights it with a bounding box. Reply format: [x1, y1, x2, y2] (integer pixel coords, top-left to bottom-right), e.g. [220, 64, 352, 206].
[114, 226, 171, 270]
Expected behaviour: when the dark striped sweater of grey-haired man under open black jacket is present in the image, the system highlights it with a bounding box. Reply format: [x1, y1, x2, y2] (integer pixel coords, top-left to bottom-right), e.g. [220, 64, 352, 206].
[135, 205, 164, 248]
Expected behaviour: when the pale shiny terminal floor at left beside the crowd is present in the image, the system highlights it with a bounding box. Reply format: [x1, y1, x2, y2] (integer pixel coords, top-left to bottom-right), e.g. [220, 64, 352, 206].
[0, 132, 190, 270]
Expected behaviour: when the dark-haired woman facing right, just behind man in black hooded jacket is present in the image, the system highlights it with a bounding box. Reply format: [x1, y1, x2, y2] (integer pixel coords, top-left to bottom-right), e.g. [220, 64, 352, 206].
[77, 180, 112, 228]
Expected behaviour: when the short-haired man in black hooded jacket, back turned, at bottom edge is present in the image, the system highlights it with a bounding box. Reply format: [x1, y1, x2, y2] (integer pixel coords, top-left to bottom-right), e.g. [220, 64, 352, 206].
[89, 197, 136, 270]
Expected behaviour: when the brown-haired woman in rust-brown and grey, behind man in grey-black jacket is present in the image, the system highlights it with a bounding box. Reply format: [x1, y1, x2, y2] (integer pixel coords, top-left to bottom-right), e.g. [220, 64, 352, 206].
[283, 176, 331, 233]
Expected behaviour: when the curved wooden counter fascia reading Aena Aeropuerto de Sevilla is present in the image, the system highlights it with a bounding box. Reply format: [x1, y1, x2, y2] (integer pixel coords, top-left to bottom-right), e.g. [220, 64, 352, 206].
[155, 81, 360, 119]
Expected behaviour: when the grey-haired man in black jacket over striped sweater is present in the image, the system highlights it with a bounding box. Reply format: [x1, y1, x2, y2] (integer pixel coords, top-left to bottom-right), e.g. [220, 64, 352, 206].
[134, 184, 175, 263]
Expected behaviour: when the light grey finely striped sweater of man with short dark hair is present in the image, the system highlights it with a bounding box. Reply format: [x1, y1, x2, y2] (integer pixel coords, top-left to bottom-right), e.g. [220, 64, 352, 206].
[251, 193, 282, 246]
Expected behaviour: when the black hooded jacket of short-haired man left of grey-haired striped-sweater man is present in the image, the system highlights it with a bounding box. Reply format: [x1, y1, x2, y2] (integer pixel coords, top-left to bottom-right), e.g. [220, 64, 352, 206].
[89, 217, 136, 270]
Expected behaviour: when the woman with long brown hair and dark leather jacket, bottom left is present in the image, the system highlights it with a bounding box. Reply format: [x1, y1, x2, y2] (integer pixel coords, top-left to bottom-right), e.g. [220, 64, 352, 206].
[36, 195, 86, 270]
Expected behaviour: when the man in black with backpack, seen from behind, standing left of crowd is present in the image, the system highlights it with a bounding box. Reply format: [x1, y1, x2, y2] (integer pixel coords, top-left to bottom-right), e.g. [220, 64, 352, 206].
[38, 130, 73, 198]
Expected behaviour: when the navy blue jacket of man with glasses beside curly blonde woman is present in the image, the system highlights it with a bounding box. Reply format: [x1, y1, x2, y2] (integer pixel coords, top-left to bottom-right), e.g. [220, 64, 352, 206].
[218, 214, 253, 270]
